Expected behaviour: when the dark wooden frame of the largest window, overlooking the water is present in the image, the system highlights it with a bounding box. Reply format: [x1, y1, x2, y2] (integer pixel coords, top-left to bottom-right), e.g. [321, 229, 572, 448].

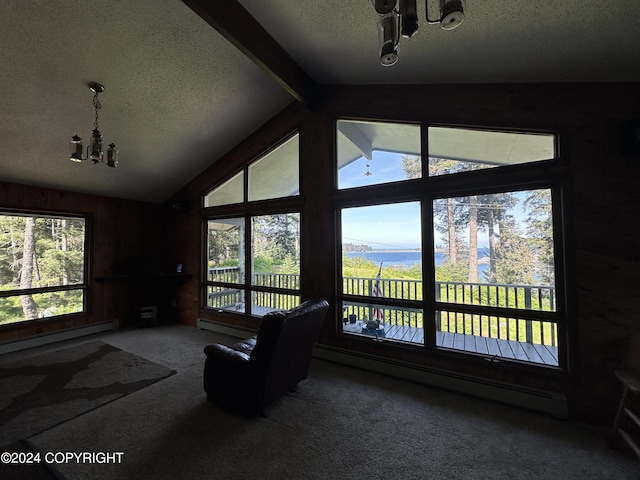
[332, 117, 571, 371]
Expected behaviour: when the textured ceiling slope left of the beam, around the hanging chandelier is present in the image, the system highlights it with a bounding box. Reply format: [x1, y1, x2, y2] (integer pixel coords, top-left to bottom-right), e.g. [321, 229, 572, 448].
[0, 0, 291, 202]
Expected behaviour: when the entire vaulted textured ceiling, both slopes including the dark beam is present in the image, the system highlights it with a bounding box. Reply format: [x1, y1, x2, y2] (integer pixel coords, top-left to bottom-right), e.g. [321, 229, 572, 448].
[0, 0, 640, 202]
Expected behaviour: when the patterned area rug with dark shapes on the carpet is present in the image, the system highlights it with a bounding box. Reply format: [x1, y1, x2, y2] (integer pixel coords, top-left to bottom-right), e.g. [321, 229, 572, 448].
[0, 341, 176, 446]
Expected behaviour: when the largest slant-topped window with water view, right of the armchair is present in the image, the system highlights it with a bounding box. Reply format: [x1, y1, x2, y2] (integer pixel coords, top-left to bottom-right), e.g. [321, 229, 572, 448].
[336, 120, 566, 367]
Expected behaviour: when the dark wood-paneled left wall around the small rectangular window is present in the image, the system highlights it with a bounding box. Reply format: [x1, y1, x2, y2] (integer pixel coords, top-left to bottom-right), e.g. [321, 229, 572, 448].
[0, 182, 163, 342]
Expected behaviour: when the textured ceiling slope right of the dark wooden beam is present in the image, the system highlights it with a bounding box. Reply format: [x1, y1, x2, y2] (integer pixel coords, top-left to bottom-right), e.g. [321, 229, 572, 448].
[240, 0, 640, 84]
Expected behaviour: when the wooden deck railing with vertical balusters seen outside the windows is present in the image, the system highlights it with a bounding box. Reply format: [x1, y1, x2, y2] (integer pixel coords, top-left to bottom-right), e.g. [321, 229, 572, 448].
[208, 267, 558, 346]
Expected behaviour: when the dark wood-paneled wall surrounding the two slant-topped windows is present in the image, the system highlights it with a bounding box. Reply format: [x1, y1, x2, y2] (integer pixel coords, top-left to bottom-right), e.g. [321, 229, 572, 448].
[166, 84, 640, 423]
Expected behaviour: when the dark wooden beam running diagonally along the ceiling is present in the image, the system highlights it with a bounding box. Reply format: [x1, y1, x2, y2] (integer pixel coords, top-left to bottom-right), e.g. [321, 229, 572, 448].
[182, 0, 320, 109]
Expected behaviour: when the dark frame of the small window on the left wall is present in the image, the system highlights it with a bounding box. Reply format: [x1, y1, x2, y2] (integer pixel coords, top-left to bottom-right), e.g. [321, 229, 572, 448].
[0, 208, 93, 328]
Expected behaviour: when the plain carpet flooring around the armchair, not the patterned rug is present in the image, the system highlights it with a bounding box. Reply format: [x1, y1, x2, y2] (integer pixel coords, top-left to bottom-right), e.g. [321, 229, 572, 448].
[0, 325, 638, 480]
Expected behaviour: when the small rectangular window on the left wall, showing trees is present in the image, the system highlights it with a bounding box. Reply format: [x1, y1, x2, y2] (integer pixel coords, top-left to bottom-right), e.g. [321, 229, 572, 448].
[0, 213, 86, 324]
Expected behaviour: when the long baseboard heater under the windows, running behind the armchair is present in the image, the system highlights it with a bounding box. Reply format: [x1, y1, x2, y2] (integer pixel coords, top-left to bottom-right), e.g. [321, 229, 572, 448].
[197, 319, 569, 419]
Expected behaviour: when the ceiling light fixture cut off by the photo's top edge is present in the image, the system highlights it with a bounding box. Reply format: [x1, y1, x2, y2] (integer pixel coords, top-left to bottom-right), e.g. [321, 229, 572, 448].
[371, 0, 465, 67]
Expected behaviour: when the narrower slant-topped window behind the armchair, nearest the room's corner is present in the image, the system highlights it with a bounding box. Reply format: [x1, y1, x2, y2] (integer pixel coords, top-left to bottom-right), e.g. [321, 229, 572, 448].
[203, 135, 300, 316]
